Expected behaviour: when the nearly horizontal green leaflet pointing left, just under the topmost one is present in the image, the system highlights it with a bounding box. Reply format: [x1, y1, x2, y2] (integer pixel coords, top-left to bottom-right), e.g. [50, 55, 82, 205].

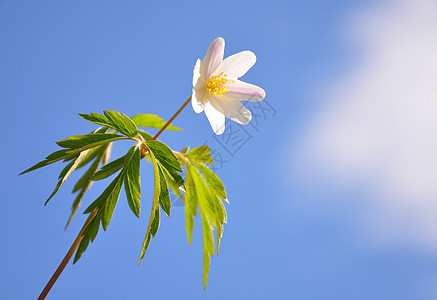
[56, 133, 130, 150]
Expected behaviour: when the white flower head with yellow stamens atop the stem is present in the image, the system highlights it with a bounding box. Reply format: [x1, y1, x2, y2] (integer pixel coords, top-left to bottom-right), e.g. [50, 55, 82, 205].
[191, 37, 266, 134]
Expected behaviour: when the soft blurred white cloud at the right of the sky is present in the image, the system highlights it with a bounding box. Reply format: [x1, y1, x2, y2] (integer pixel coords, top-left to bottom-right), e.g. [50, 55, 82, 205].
[294, 0, 437, 250]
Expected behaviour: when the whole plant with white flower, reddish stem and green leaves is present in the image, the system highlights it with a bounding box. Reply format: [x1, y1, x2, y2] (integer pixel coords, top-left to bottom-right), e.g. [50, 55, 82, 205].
[21, 38, 265, 299]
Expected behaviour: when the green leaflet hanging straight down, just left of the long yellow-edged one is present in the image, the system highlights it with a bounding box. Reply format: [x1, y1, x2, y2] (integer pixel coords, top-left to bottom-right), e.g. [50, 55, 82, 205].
[124, 146, 141, 218]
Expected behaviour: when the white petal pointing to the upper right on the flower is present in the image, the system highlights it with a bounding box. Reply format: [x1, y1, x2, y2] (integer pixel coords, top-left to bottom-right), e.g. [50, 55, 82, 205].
[214, 51, 256, 79]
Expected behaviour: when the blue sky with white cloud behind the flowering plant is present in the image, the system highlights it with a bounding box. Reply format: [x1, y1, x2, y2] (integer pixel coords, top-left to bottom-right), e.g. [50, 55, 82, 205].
[0, 0, 437, 299]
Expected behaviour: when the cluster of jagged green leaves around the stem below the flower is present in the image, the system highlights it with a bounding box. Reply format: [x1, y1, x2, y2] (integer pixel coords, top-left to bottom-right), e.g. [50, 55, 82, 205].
[21, 111, 227, 288]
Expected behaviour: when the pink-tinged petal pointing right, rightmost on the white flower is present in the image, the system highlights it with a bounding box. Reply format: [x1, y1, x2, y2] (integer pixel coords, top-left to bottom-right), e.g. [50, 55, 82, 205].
[222, 80, 266, 102]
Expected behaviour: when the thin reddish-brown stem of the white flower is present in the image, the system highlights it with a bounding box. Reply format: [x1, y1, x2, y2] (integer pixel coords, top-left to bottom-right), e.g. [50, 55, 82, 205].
[38, 96, 191, 300]
